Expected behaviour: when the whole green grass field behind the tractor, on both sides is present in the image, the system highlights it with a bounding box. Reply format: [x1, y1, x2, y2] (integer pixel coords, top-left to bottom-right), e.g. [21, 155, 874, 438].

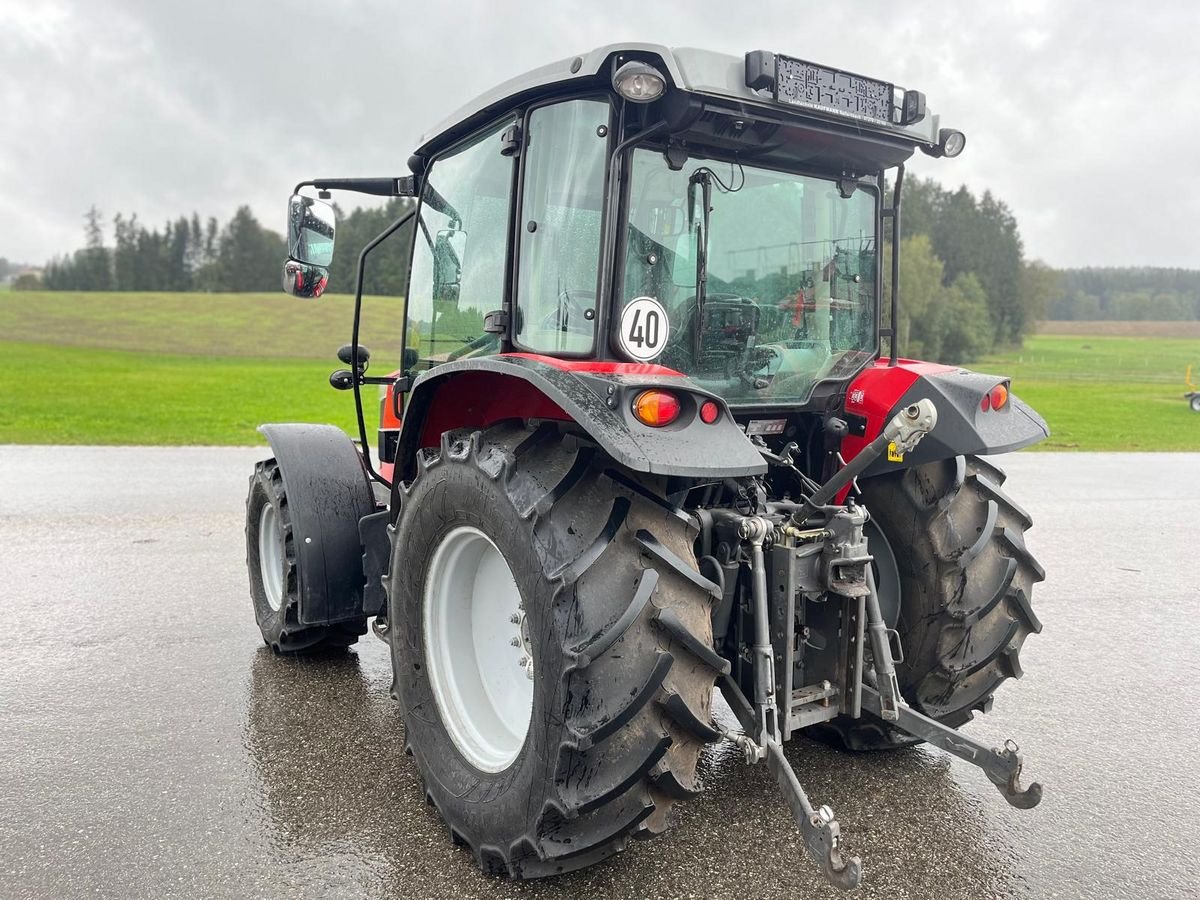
[0, 292, 1200, 450]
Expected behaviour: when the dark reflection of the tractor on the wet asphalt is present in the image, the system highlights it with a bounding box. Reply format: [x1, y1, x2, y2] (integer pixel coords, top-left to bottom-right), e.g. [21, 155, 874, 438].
[246, 648, 1014, 898]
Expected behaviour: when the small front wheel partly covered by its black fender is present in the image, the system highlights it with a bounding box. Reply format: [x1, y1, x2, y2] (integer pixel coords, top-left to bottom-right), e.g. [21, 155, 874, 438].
[246, 460, 366, 653]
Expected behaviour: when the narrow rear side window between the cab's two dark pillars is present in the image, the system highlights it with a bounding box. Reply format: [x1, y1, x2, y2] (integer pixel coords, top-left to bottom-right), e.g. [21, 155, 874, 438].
[514, 100, 608, 353]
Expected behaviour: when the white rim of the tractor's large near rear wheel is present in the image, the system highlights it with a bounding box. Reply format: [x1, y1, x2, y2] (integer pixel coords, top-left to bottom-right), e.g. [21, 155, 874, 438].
[424, 526, 534, 772]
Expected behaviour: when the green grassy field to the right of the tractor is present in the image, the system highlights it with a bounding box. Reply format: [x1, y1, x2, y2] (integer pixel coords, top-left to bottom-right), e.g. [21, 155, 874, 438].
[971, 335, 1200, 450]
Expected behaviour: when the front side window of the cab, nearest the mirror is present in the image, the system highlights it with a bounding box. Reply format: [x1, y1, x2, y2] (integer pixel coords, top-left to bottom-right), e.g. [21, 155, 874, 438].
[407, 121, 514, 366]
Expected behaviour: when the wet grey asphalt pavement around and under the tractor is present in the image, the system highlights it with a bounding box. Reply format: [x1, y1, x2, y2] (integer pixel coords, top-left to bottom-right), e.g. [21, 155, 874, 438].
[0, 446, 1200, 900]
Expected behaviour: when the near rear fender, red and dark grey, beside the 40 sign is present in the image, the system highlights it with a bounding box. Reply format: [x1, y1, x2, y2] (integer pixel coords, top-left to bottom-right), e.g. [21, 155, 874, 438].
[396, 353, 767, 480]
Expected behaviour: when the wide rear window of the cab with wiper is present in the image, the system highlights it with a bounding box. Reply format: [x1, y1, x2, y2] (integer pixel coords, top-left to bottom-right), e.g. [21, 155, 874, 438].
[622, 149, 878, 406]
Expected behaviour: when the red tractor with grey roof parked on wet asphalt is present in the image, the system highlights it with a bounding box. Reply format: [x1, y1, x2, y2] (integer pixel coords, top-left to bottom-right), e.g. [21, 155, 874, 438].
[246, 44, 1048, 888]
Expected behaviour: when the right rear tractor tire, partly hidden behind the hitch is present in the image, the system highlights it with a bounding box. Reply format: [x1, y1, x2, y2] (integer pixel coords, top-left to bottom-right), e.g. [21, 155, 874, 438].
[810, 456, 1045, 750]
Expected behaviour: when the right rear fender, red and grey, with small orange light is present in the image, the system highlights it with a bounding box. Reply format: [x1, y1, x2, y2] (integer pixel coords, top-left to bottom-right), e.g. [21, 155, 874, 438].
[841, 360, 1050, 476]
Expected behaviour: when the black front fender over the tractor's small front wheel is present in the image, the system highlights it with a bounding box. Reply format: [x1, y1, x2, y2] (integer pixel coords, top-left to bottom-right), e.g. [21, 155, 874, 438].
[258, 425, 386, 625]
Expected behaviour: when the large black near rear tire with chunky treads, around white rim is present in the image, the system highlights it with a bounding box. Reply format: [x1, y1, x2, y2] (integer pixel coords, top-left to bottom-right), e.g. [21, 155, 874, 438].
[388, 425, 727, 878]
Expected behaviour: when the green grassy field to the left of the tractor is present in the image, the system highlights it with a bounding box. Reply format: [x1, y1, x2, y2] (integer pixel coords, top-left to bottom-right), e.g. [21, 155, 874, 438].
[0, 292, 393, 444]
